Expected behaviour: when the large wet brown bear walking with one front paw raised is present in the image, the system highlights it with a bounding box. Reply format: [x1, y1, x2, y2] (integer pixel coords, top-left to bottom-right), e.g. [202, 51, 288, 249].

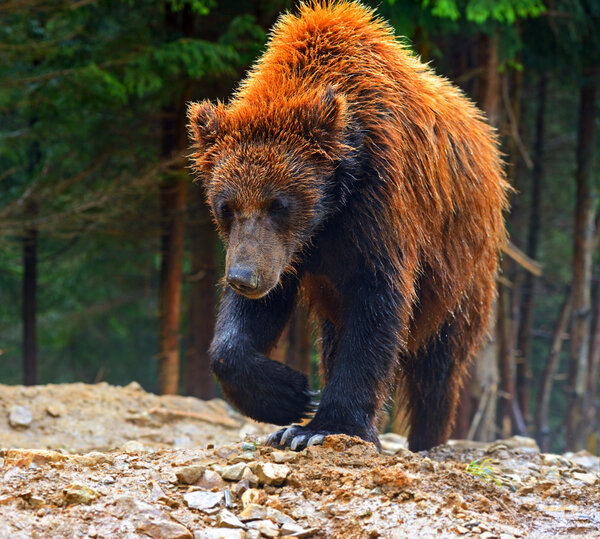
[189, 1, 507, 451]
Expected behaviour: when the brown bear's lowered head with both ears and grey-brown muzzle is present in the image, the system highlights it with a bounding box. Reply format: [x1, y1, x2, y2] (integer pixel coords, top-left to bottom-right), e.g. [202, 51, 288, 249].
[188, 87, 349, 299]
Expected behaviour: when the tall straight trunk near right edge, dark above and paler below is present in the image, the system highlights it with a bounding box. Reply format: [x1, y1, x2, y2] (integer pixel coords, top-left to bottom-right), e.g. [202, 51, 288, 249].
[566, 67, 597, 451]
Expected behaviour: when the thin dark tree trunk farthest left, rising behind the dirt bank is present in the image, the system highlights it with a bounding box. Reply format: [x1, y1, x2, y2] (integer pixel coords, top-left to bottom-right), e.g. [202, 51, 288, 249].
[23, 202, 37, 386]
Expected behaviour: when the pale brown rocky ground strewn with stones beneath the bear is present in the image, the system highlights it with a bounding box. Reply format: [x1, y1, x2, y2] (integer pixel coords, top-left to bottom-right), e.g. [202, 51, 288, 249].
[0, 383, 600, 539]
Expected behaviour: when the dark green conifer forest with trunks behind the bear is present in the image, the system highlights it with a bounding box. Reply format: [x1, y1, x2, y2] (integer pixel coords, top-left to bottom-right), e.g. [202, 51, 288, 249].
[0, 0, 600, 453]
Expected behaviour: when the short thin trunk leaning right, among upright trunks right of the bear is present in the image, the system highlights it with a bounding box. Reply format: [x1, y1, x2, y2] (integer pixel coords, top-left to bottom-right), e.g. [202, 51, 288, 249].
[535, 290, 573, 452]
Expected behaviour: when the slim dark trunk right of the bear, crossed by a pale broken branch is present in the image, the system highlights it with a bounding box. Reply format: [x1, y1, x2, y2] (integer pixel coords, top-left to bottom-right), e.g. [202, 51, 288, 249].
[517, 73, 548, 426]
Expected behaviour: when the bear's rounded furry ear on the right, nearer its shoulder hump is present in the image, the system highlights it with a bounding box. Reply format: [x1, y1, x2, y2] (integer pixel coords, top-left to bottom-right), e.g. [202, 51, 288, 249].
[306, 86, 348, 159]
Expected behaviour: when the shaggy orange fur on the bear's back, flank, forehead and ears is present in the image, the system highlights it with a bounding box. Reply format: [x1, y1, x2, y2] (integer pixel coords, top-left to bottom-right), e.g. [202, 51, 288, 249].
[190, 1, 508, 452]
